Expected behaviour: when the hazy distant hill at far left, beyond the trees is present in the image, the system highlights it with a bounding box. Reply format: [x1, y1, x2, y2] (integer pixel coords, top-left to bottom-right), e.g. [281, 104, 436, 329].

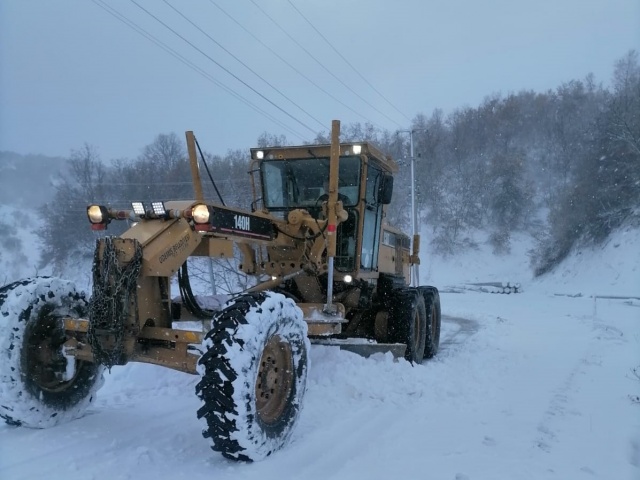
[0, 151, 67, 207]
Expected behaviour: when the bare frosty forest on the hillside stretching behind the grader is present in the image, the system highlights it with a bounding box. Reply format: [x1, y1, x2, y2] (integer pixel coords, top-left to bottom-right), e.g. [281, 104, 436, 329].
[0, 51, 640, 282]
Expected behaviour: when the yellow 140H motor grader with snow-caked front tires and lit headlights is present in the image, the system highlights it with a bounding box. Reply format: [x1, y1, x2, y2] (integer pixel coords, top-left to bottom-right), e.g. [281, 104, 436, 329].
[0, 121, 440, 461]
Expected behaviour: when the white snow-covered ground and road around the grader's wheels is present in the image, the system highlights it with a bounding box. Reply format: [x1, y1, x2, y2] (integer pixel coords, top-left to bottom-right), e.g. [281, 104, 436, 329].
[0, 229, 640, 480]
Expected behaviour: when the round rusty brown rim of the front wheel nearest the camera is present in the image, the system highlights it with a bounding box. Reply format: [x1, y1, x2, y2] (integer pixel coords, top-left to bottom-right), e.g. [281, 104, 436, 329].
[256, 335, 294, 424]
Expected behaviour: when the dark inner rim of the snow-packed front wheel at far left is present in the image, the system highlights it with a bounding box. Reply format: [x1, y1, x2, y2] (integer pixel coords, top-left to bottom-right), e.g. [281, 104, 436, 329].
[25, 314, 79, 392]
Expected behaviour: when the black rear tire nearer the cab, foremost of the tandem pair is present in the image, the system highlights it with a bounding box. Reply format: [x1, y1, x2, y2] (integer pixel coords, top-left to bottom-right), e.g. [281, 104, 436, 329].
[389, 288, 427, 363]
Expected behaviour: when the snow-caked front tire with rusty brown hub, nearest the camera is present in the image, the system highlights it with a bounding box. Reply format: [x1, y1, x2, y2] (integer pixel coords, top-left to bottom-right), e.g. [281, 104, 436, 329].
[196, 292, 311, 461]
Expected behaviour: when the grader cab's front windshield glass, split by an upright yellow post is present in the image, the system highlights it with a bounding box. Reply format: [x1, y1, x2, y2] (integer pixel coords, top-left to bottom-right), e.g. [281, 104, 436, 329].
[260, 156, 360, 210]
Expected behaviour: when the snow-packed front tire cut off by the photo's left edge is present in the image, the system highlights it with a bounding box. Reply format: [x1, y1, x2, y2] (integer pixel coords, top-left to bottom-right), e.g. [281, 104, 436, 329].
[0, 277, 104, 428]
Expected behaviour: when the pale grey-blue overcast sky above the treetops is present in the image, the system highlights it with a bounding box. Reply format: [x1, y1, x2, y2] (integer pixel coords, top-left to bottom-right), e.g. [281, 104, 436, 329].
[0, 0, 640, 159]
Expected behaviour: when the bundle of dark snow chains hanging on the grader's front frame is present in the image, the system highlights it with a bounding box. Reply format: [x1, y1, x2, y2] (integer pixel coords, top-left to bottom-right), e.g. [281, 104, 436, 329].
[87, 237, 142, 370]
